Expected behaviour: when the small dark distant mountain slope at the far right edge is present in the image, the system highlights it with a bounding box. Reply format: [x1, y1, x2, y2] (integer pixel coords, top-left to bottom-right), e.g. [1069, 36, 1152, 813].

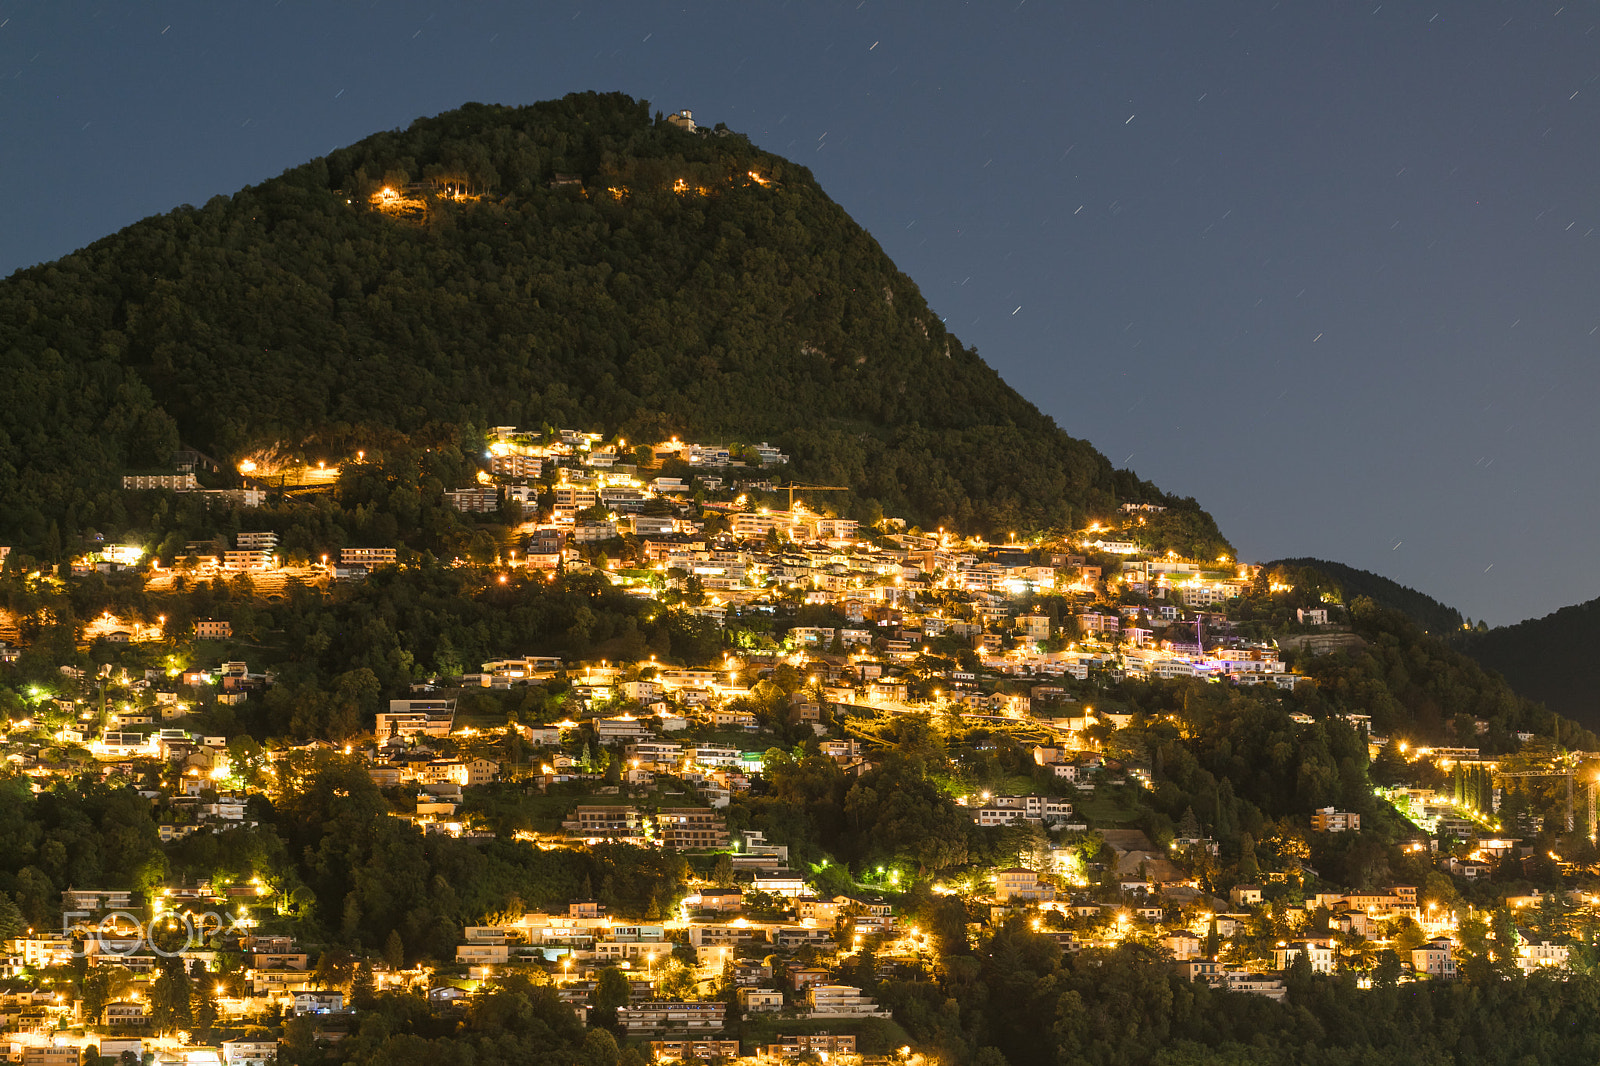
[1459, 599, 1600, 728]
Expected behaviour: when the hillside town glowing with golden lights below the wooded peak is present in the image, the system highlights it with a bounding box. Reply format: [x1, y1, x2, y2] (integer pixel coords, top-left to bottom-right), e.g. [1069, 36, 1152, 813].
[0, 425, 1580, 1064]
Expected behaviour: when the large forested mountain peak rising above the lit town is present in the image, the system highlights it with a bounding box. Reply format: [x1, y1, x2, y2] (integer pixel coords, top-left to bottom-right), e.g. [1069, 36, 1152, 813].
[0, 93, 1229, 557]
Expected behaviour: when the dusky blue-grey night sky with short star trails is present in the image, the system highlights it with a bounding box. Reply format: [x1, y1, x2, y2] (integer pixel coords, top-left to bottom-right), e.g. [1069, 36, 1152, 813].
[0, 0, 1600, 623]
